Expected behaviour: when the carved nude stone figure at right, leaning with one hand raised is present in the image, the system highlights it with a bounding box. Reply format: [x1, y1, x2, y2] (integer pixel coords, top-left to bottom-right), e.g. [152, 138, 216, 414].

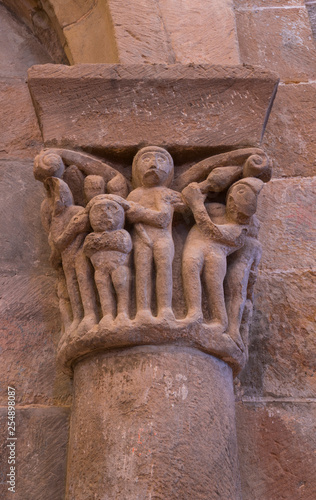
[182, 178, 263, 338]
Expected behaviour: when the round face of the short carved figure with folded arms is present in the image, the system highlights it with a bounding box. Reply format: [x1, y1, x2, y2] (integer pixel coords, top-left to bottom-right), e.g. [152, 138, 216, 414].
[90, 200, 124, 232]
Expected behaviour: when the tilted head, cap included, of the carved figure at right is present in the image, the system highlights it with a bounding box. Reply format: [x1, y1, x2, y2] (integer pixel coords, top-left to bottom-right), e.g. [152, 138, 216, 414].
[226, 177, 263, 224]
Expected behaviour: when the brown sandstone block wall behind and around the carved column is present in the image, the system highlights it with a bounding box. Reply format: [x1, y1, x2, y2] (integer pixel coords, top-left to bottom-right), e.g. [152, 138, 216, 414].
[0, 0, 316, 500]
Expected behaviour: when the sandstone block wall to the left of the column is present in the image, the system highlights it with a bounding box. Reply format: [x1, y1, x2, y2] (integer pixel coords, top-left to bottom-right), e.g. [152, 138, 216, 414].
[0, 5, 70, 500]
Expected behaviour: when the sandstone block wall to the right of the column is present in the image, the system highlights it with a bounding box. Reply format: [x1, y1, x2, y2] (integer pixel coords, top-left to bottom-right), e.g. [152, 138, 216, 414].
[235, 0, 316, 500]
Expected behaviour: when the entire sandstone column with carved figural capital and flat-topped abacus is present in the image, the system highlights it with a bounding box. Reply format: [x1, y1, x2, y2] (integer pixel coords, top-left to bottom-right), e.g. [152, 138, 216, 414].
[29, 65, 276, 500]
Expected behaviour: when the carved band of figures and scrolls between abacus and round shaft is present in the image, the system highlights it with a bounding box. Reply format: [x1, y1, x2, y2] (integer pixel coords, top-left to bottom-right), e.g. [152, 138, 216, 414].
[34, 146, 271, 370]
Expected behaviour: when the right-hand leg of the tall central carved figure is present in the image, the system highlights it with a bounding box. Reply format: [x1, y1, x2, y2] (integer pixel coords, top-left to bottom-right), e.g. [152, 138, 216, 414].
[154, 238, 175, 320]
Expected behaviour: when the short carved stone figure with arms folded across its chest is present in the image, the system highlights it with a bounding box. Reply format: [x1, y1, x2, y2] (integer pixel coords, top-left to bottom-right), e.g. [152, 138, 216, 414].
[83, 195, 132, 325]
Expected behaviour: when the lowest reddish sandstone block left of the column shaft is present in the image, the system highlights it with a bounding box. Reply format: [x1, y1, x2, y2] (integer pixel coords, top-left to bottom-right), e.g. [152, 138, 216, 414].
[0, 406, 69, 500]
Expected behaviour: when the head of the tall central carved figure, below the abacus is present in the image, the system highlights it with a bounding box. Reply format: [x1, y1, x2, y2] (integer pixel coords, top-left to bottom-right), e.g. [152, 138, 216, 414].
[132, 146, 174, 188]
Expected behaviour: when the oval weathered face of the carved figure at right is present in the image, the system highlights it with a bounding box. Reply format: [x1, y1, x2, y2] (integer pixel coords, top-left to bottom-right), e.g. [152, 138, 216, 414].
[226, 184, 257, 223]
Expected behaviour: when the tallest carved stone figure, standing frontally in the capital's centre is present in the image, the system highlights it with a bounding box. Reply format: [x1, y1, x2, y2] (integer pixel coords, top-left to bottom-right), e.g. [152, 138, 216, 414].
[126, 146, 184, 320]
